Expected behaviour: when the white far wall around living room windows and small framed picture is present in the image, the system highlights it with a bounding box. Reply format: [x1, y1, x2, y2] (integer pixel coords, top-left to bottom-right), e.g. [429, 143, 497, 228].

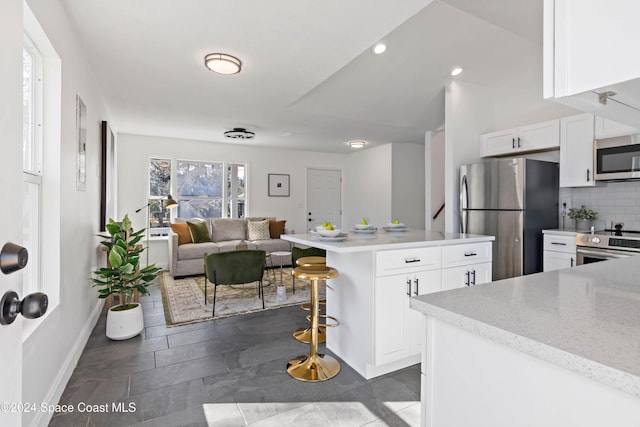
[116, 134, 346, 265]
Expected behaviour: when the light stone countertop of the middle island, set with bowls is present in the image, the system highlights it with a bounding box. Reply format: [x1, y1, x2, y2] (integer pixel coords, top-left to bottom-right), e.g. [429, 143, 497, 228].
[280, 229, 495, 253]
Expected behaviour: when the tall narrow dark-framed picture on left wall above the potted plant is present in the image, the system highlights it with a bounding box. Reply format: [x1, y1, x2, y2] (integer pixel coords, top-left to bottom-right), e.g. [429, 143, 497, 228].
[99, 120, 115, 231]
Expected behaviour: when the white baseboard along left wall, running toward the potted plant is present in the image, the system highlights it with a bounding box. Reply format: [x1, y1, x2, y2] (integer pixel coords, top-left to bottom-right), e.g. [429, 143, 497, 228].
[32, 299, 104, 426]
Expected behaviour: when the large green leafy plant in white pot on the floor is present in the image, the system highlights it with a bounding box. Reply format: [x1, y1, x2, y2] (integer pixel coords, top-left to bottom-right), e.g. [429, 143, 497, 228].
[92, 215, 160, 340]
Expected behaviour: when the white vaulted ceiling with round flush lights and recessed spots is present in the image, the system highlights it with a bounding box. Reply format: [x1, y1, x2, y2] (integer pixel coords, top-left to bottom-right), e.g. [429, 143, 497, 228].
[62, 0, 542, 153]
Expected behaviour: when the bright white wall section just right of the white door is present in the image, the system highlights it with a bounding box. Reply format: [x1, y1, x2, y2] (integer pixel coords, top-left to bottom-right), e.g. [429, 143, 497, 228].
[342, 144, 392, 229]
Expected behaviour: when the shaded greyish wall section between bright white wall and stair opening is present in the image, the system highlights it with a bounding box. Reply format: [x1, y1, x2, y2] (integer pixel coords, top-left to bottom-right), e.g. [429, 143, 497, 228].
[391, 142, 425, 230]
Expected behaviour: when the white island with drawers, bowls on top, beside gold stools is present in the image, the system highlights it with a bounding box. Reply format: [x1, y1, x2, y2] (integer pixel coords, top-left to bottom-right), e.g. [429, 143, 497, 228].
[281, 230, 493, 379]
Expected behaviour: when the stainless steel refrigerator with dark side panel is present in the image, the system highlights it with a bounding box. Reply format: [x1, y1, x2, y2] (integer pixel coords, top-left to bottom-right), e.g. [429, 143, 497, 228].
[460, 158, 559, 280]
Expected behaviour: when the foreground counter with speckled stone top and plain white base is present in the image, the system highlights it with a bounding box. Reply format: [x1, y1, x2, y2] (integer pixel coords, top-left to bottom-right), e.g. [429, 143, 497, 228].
[411, 257, 640, 427]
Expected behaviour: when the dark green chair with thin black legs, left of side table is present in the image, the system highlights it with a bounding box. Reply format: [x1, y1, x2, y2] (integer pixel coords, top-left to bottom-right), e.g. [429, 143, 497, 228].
[204, 249, 266, 317]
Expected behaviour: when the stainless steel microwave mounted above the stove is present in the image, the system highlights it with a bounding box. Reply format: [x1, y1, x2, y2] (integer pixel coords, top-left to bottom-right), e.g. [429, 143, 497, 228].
[593, 134, 640, 181]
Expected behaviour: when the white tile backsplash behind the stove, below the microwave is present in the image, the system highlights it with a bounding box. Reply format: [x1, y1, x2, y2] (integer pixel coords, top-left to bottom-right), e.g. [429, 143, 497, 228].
[559, 181, 640, 230]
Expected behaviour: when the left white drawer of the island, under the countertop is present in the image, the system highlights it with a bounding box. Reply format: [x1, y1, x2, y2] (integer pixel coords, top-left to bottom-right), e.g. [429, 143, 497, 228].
[376, 247, 442, 276]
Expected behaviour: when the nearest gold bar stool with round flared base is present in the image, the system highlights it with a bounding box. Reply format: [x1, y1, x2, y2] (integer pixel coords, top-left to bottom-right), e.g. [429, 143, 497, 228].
[287, 265, 340, 382]
